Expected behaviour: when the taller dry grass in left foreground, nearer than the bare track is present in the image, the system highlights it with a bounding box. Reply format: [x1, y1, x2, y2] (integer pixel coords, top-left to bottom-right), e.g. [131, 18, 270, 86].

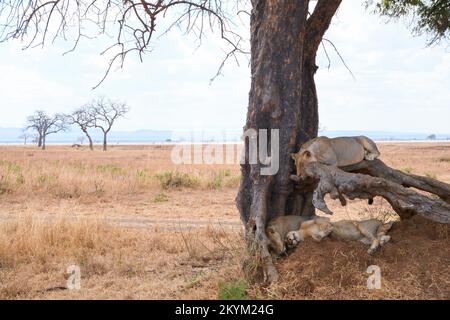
[0, 215, 242, 299]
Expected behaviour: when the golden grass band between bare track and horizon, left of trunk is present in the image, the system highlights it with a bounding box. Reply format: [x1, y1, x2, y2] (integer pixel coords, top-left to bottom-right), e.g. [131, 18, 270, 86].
[0, 146, 243, 199]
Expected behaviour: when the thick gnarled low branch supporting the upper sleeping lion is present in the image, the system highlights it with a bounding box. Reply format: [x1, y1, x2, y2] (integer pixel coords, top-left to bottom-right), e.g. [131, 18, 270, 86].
[291, 160, 450, 223]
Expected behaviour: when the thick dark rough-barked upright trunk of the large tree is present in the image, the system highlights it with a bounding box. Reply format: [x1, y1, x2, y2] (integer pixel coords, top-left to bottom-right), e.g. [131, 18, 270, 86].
[236, 0, 341, 282]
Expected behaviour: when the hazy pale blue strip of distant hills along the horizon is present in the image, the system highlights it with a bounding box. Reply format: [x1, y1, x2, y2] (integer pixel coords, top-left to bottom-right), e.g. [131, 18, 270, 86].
[0, 128, 450, 144]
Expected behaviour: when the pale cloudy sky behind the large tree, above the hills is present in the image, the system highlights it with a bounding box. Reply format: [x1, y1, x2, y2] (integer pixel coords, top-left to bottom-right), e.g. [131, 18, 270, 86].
[0, 1, 450, 133]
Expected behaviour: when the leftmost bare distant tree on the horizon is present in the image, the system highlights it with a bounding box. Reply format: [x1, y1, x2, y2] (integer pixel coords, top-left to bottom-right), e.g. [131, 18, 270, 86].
[26, 110, 67, 150]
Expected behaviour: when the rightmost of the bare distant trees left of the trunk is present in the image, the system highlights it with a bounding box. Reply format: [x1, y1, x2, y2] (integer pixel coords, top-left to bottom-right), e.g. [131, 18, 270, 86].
[90, 98, 130, 151]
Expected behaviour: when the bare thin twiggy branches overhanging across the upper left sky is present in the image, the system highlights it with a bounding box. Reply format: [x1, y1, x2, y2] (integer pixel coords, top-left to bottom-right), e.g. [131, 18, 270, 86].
[0, 0, 248, 88]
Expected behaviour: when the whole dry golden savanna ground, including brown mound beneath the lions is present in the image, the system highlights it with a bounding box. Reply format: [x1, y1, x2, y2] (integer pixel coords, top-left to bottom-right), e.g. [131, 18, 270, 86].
[0, 143, 450, 299]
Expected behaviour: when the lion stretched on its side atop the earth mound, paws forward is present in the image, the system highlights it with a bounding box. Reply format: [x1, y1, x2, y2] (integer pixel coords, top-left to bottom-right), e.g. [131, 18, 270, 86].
[286, 217, 393, 254]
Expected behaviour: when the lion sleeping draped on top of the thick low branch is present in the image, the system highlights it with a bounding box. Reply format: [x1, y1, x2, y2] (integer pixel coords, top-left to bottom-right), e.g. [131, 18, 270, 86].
[291, 136, 380, 176]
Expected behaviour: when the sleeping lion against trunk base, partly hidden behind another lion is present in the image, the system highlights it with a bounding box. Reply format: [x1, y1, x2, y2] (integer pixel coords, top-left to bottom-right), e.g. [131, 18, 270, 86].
[266, 215, 314, 255]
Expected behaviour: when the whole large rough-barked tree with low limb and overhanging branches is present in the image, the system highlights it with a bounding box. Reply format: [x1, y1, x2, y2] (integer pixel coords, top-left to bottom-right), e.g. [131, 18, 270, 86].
[0, 0, 450, 281]
